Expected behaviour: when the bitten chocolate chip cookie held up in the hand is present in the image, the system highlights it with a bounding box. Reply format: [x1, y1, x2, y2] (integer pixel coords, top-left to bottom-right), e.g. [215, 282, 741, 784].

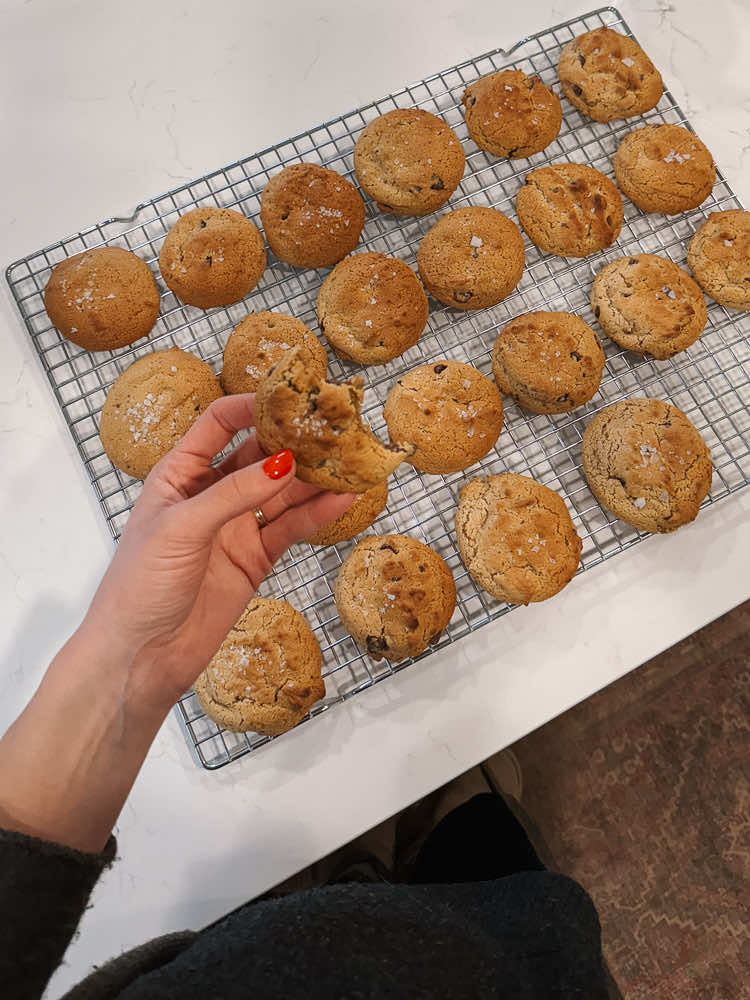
[255, 347, 412, 493]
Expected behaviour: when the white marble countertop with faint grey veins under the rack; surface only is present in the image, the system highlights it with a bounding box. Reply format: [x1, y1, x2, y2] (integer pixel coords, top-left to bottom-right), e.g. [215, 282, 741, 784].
[0, 0, 750, 997]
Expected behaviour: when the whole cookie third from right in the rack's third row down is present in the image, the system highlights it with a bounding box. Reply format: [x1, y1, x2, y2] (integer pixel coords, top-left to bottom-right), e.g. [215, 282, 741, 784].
[492, 312, 604, 413]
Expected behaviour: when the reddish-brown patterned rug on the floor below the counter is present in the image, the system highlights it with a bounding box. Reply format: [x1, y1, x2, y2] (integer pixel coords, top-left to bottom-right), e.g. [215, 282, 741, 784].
[513, 602, 750, 1000]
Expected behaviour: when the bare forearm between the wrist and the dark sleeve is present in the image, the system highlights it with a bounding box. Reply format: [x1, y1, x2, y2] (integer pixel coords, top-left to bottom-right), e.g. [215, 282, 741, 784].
[0, 621, 169, 852]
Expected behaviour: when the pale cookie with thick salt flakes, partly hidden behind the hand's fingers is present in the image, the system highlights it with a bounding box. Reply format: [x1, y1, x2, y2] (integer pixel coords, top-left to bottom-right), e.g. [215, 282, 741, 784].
[99, 347, 222, 479]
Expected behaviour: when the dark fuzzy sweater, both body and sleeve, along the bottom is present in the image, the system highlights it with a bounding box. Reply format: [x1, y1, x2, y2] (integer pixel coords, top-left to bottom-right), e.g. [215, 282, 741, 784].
[0, 831, 607, 1000]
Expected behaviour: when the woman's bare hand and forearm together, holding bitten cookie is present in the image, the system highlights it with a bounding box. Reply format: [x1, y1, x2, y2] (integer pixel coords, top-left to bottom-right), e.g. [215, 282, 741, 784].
[0, 396, 352, 851]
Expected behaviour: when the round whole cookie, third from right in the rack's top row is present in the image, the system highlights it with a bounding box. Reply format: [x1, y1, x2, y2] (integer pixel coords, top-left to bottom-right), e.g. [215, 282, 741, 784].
[354, 108, 466, 215]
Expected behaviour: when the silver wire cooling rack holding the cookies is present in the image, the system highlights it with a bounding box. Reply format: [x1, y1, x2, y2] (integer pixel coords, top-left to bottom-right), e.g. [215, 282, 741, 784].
[6, 7, 750, 768]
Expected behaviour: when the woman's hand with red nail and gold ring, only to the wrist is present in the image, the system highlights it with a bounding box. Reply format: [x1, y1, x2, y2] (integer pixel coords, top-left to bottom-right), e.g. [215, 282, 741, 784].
[84, 396, 353, 705]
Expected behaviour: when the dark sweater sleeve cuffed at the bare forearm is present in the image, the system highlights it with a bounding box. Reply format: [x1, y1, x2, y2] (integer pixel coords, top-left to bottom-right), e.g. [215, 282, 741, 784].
[0, 830, 117, 1000]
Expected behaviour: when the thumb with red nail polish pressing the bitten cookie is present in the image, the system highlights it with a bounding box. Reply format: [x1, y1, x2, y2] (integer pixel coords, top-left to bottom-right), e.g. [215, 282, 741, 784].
[180, 449, 294, 538]
